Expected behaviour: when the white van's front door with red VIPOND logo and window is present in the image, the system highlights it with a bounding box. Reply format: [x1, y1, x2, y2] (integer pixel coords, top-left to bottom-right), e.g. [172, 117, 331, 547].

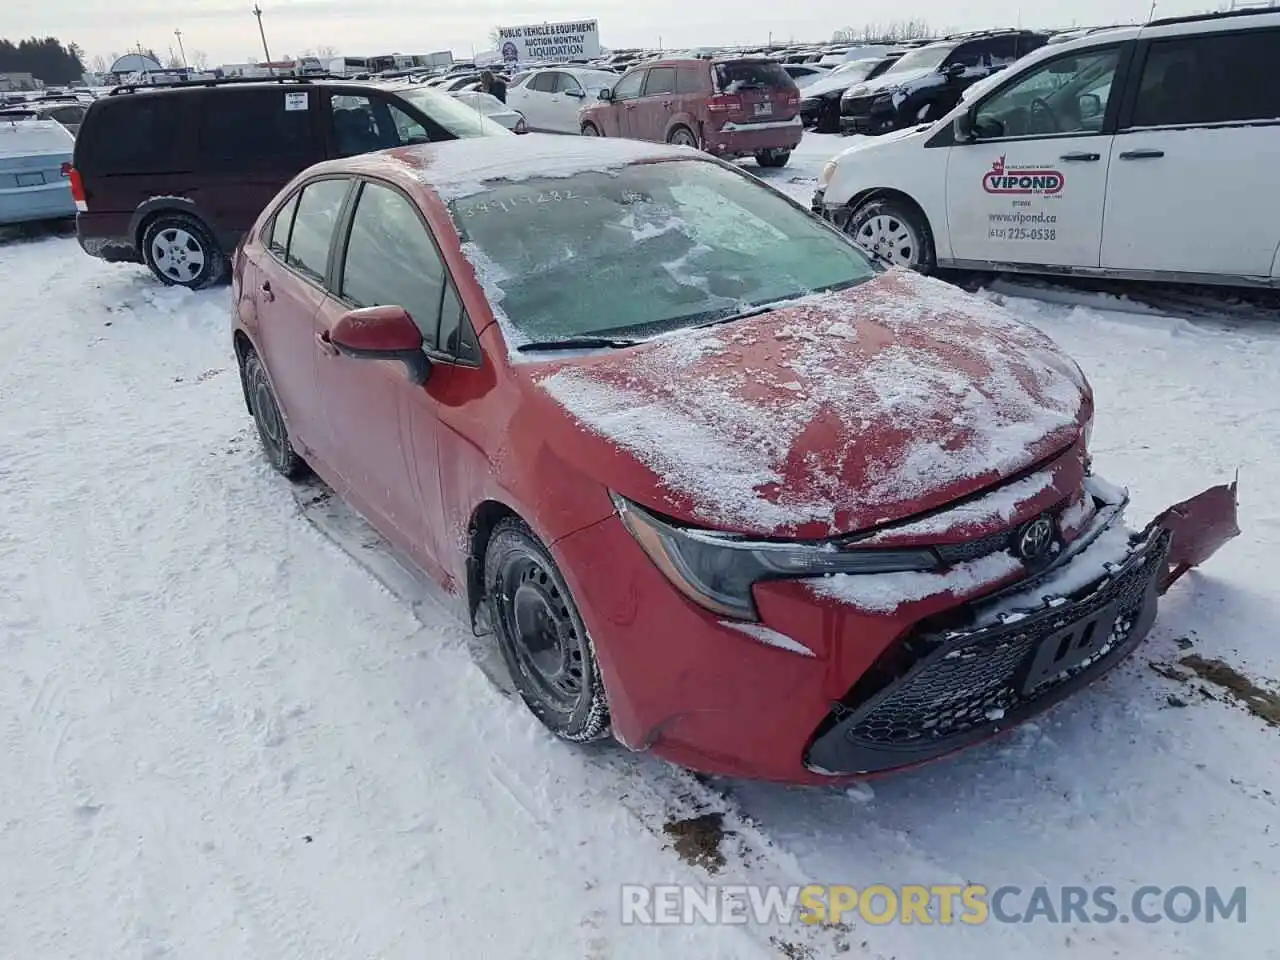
[946, 44, 1125, 266]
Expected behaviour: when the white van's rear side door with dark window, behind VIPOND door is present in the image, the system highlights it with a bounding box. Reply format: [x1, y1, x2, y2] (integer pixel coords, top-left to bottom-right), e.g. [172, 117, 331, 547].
[1102, 27, 1280, 278]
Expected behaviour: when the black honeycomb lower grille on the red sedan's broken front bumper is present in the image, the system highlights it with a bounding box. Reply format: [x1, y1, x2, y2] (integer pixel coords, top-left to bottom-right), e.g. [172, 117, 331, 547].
[805, 527, 1171, 776]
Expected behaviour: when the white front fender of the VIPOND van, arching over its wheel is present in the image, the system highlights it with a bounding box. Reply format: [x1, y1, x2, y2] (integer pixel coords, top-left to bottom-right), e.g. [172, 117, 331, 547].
[823, 125, 951, 257]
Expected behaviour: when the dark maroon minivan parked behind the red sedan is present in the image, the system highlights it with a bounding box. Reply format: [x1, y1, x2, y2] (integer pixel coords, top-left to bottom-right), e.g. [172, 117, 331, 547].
[72, 77, 512, 289]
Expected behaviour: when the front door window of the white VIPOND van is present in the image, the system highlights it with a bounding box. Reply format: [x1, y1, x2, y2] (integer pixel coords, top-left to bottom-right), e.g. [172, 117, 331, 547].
[973, 47, 1120, 140]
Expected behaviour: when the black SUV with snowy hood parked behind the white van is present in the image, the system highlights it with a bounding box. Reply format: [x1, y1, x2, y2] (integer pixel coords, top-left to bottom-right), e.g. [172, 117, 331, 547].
[840, 29, 1050, 134]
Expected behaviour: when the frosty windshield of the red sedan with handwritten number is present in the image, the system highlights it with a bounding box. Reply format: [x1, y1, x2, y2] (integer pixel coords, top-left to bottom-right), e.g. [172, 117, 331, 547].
[451, 160, 874, 346]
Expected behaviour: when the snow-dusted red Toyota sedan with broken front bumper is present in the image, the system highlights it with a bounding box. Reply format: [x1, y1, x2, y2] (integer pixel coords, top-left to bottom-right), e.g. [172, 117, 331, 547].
[234, 136, 1235, 782]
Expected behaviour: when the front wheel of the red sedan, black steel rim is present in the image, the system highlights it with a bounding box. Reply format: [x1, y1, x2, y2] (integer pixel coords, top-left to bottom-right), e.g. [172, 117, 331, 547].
[484, 517, 609, 744]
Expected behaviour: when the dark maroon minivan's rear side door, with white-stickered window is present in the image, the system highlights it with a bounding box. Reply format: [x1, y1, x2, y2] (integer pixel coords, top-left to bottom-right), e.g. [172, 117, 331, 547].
[189, 84, 324, 234]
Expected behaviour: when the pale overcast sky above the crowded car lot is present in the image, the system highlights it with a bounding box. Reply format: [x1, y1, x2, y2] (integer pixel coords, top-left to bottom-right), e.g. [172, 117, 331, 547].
[17, 0, 1198, 64]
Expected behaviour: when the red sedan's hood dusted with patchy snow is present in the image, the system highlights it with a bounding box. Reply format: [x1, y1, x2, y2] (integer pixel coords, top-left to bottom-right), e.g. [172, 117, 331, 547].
[530, 271, 1092, 538]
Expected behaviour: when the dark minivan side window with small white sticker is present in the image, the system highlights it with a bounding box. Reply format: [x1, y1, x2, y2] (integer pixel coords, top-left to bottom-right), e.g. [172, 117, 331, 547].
[200, 87, 320, 173]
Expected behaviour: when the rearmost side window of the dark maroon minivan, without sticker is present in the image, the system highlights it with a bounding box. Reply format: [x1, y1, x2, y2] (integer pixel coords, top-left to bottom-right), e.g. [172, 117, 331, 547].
[77, 93, 184, 174]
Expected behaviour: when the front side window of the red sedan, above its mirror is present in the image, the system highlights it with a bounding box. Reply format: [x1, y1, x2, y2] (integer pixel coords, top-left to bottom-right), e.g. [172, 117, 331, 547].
[340, 183, 444, 347]
